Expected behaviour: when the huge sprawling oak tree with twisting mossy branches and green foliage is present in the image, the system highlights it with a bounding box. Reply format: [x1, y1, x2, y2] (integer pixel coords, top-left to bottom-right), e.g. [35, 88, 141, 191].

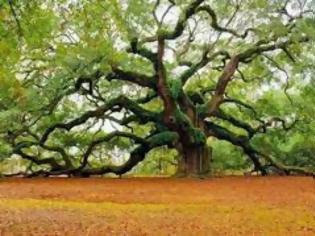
[0, 0, 315, 176]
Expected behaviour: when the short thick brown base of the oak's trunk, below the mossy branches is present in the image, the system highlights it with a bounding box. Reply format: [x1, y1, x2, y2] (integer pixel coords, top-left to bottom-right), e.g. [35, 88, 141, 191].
[176, 146, 212, 177]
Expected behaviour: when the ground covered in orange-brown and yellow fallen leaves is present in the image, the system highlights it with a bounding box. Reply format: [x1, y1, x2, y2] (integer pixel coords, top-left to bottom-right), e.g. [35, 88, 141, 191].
[0, 177, 315, 236]
